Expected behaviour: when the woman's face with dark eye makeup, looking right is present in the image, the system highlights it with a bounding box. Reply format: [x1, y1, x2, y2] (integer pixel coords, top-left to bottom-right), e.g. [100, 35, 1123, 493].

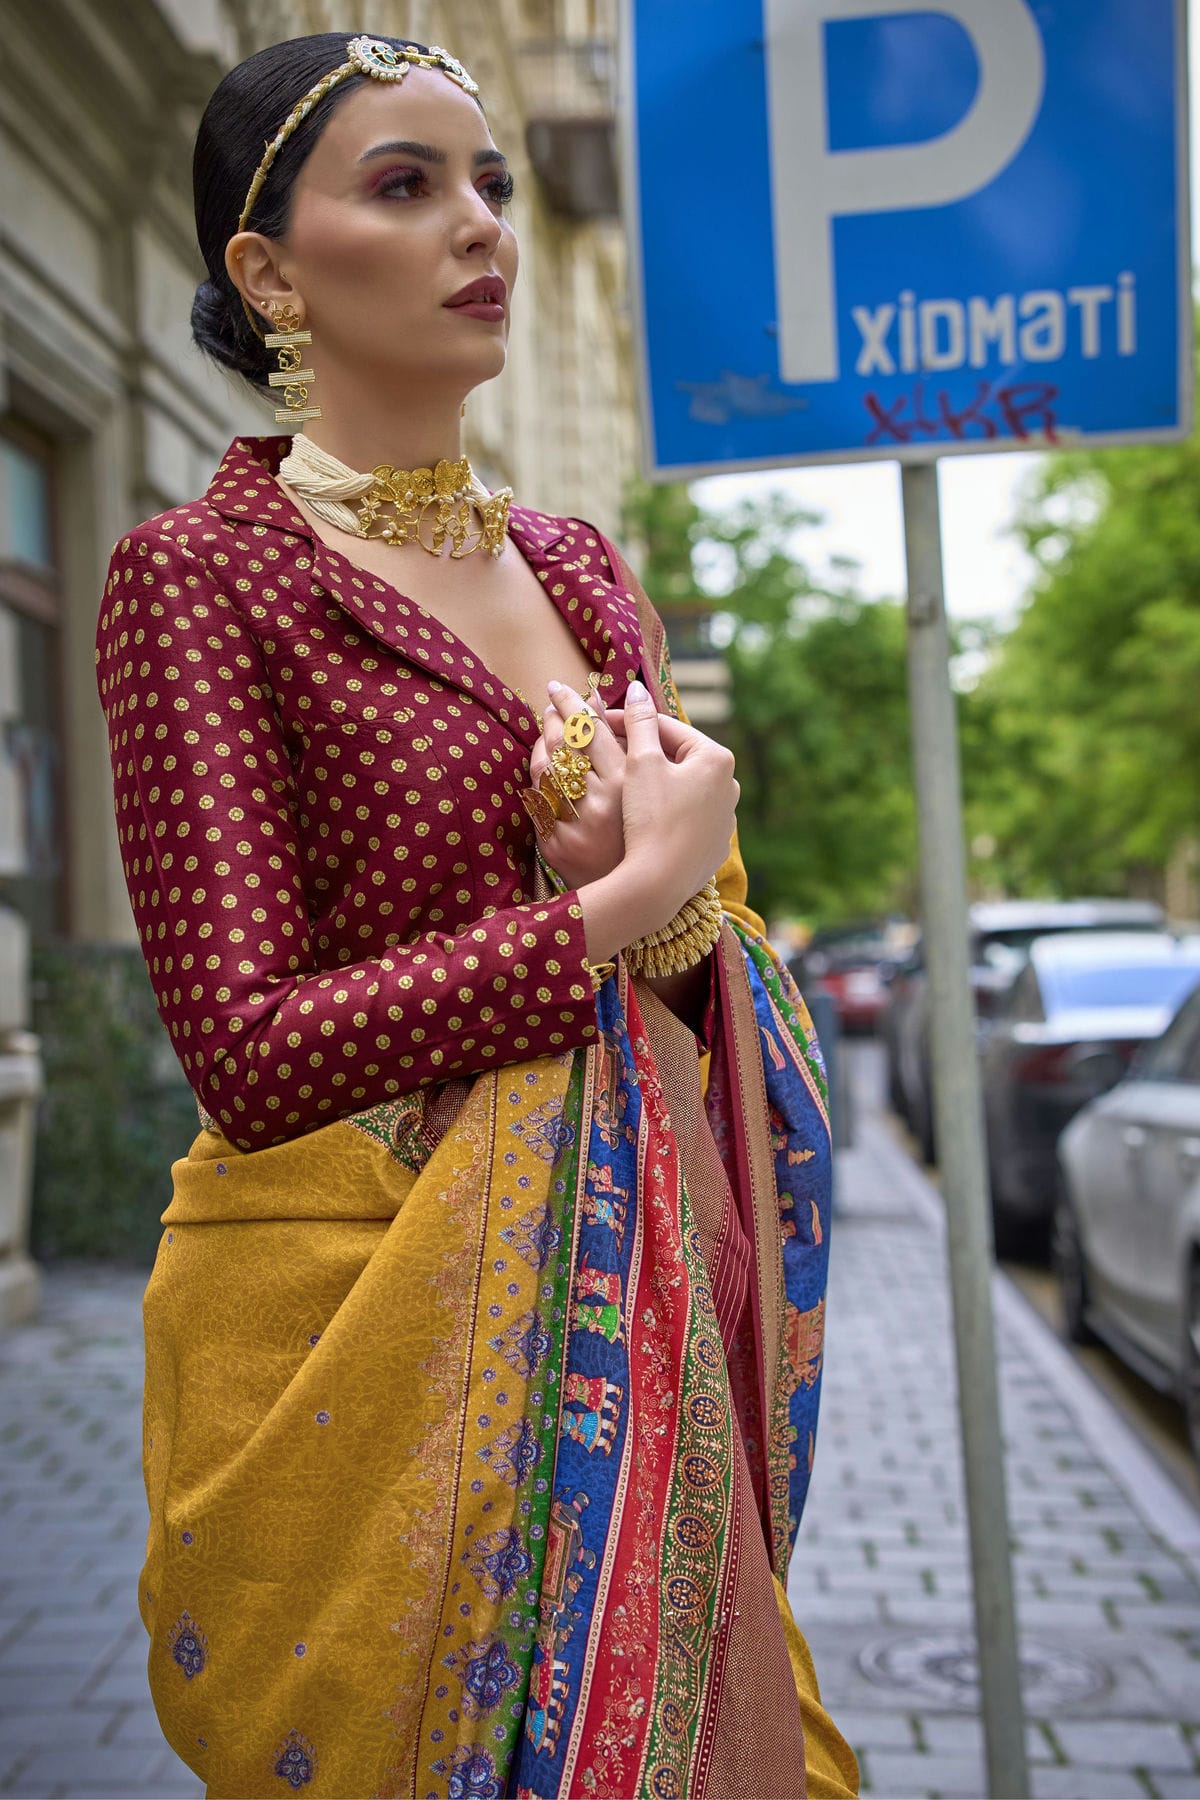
[269, 68, 518, 392]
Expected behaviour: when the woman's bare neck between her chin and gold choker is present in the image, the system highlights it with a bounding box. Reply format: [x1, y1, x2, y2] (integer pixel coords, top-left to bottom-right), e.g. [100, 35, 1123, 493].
[304, 369, 462, 473]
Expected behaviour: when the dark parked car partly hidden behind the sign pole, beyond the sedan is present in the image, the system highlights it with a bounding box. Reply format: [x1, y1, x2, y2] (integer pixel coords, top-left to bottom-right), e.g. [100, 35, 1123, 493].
[880, 900, 1166, 1163]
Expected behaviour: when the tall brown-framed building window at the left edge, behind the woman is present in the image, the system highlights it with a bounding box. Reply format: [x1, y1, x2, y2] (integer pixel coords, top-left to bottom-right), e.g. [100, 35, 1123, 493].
[0, 418, 67, 940]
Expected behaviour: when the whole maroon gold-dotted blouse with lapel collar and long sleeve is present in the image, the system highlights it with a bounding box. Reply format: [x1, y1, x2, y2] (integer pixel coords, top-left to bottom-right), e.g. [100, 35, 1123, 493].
[97, 437, 642, 1150]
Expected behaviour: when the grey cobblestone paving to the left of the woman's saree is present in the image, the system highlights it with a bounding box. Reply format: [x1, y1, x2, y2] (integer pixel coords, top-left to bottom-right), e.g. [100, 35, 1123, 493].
[0, 1267, 203, 1800]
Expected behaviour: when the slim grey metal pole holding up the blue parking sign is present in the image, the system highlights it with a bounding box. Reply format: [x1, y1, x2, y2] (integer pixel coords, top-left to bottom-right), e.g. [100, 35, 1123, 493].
[901, 463, 1029, 1800]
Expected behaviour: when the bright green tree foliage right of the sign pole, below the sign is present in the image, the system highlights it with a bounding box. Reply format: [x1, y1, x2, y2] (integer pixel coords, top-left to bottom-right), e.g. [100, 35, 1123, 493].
[964, 428, 1200, 893]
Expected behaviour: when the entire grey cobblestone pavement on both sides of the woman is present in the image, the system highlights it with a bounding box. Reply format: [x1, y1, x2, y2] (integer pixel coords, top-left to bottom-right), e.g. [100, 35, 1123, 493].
[0, 1044, 1200, 1800]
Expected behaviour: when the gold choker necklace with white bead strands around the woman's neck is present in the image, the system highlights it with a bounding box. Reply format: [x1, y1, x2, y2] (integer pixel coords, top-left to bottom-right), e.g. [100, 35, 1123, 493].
[279, 432, 513, 556]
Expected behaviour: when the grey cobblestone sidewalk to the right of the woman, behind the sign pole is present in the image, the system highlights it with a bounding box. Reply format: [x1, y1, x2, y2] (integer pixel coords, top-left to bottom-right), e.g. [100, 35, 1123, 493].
[790, 1046, 1200, 1800]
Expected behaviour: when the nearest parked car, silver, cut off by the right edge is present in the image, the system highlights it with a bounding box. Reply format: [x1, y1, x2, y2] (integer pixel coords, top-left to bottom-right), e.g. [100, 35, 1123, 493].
[1052, 986, 1200, 1460]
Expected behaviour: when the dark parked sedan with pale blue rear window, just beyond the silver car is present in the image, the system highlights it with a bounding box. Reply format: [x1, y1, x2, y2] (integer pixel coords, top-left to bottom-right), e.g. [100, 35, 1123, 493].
[981, 931, 1200, 1249]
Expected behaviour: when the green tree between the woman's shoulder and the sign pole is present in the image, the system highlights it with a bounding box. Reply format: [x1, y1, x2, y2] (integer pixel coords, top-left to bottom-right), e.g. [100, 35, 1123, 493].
[626, 488, 916, 922]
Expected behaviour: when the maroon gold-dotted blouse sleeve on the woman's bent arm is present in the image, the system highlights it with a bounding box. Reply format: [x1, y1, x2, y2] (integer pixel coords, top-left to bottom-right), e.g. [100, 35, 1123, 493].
[95, 533, 596, 1150]
